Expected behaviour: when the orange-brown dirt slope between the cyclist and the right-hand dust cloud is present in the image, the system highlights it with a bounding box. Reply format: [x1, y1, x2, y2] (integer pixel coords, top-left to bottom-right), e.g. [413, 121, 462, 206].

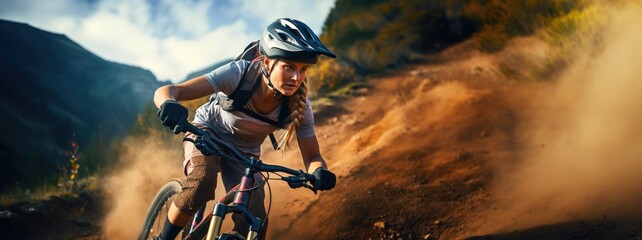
[264, 40, 518, 239]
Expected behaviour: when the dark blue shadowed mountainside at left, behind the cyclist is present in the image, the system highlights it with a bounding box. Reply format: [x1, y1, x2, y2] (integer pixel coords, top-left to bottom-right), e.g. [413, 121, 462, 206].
[0, 20, 161, 189]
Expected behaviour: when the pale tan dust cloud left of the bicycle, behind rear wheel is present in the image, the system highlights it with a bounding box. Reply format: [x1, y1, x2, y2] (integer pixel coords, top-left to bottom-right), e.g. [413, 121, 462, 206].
[103, 136, 183, 239]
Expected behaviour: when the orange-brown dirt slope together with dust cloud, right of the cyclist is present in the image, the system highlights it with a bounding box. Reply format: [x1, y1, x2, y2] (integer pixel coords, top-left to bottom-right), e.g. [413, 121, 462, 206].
[272, 5, 642, 239]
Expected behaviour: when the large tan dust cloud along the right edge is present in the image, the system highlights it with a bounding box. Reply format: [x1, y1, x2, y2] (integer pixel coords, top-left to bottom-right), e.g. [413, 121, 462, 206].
[484, 5, 642, 232]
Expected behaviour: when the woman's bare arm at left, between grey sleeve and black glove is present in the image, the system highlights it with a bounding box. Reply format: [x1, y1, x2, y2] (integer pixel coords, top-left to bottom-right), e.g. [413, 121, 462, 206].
[154, 76, 214, 108]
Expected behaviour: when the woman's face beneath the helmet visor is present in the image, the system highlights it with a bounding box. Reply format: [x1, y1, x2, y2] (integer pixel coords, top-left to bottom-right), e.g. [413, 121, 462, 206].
[266, 59, 310, 96]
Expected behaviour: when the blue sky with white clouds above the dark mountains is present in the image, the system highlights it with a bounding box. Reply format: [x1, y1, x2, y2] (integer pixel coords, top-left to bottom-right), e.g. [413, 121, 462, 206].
[0, 0, 334, 82]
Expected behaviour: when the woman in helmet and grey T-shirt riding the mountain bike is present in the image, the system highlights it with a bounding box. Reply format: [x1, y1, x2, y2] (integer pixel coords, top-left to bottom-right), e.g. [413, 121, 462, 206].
[154, 18, 336, 239]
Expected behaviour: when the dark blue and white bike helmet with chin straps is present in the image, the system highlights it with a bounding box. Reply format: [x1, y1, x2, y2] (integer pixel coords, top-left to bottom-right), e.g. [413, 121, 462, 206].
[259, 18, 337, 98]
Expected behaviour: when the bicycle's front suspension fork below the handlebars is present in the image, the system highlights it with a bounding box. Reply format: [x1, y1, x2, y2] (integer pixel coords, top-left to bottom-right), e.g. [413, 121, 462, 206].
[206, 169, 261, 240]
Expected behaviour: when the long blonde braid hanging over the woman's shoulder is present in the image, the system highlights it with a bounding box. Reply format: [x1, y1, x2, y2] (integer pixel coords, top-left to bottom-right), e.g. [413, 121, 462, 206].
[279, 78, 308, 152]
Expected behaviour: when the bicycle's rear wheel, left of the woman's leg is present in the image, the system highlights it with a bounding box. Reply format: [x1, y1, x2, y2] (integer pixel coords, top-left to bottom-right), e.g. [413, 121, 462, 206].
[138, 179, 183, 240]
